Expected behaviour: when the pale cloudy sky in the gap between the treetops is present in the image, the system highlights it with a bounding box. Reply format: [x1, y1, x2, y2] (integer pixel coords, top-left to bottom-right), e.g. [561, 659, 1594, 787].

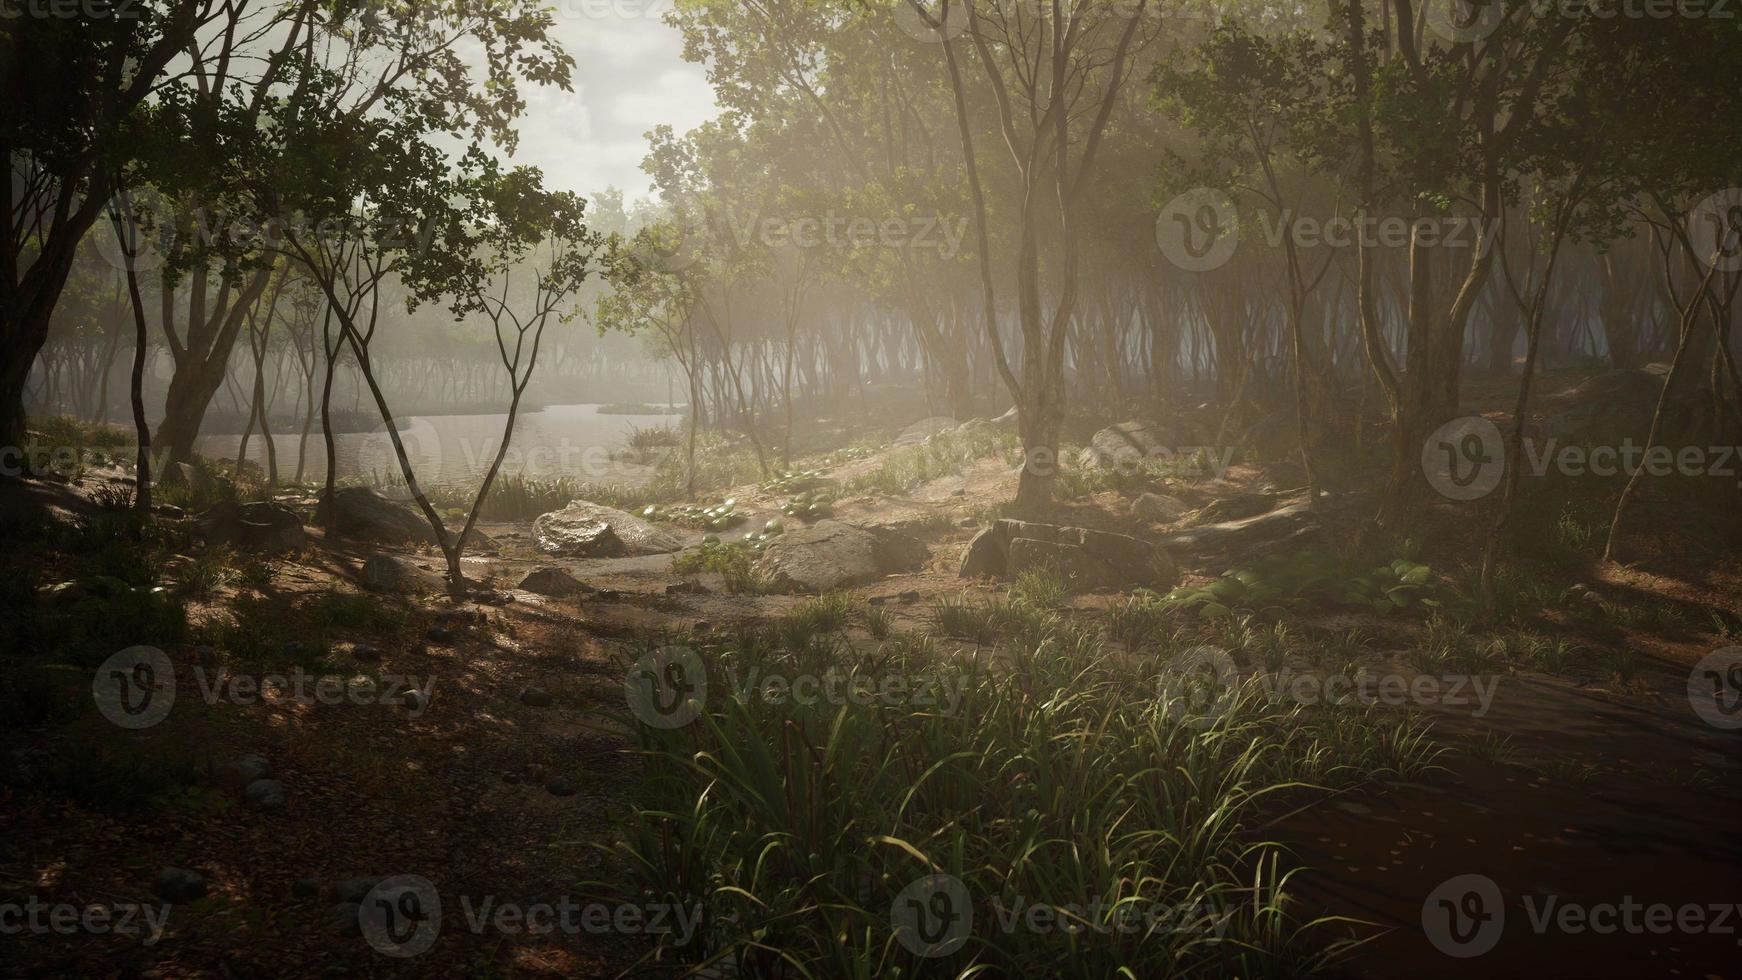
[514, 0, 719, 200]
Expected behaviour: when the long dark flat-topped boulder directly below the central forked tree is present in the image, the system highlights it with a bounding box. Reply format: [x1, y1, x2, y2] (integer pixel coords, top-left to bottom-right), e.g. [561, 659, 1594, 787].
[962, 520, 1179, 592]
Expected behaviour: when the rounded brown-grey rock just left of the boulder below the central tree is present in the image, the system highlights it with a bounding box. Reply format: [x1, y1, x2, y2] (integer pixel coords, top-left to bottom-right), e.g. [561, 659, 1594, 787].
[756, 520, 930, 592]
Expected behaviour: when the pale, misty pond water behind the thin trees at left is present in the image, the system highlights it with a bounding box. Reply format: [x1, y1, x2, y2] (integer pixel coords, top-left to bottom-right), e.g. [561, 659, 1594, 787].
[197, 406, 681, 486]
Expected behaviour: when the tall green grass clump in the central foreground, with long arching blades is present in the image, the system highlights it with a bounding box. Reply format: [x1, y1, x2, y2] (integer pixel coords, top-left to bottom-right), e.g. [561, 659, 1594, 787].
[599, 641, 1439, 978]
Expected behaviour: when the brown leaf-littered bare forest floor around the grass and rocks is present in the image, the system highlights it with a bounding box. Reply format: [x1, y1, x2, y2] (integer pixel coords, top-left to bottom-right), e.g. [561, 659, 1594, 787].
[0, 388, 1742, 978]
